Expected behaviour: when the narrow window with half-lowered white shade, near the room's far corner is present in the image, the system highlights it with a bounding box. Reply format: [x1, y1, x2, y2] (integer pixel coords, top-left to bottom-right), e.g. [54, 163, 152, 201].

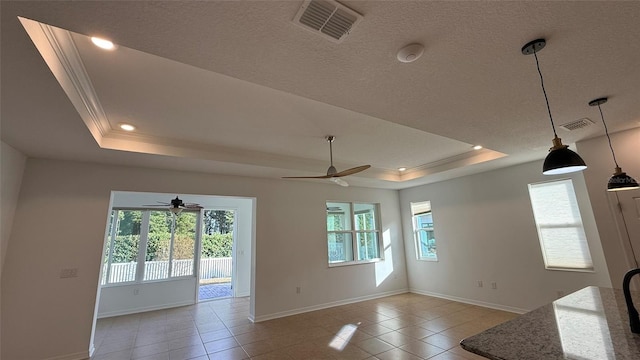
[411, 201, 438, 261]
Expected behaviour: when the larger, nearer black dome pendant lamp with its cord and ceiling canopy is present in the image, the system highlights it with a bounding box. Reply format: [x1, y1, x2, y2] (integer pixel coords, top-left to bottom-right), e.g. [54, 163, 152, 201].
[522, 39, 587, 175]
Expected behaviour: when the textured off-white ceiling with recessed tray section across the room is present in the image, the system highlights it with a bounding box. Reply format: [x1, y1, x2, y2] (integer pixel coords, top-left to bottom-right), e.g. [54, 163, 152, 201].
[0, 1, 640, 188]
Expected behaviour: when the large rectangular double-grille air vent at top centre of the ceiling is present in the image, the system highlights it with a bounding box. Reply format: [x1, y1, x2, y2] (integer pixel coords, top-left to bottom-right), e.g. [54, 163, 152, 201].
[293, 0, 362, 43]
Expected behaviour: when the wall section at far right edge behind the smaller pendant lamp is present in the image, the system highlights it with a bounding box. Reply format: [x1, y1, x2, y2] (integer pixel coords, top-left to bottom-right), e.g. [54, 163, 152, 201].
[576, 128, 640, 288]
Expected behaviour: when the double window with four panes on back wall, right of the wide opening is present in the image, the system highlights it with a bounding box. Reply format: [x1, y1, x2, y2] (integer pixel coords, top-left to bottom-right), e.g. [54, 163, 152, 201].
[327, 202, 382, 264]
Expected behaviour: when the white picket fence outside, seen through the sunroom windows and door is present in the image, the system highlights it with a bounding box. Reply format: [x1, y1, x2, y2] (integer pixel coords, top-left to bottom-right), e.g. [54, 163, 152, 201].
[102, 257, 232, 285]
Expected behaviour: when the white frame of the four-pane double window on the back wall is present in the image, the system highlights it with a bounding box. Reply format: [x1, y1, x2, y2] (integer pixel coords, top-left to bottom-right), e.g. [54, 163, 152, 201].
[324, 200, 384, 267]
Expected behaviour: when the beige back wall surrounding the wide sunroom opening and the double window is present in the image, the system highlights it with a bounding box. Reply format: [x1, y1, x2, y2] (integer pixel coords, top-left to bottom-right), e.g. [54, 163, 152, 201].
[2, 159, 407, 360]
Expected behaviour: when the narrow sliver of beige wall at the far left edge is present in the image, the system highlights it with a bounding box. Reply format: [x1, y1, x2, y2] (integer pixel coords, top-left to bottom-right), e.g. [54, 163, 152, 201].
[0, 142, 27, 360]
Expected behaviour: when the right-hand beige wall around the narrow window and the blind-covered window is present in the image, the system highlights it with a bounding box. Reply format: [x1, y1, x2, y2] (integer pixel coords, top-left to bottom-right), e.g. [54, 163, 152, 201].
[400, 162, 610, 311]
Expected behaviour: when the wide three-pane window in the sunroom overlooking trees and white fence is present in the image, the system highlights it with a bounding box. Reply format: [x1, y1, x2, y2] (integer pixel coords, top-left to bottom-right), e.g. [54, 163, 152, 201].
[101, 209, 199, 285]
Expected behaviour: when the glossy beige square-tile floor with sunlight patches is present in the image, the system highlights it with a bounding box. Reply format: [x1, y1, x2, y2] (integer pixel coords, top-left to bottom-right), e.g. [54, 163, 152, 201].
[92, 293, 517, 360]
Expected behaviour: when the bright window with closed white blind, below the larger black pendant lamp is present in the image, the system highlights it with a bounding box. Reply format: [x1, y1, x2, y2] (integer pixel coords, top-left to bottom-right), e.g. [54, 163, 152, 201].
[529, 179, 593, 270]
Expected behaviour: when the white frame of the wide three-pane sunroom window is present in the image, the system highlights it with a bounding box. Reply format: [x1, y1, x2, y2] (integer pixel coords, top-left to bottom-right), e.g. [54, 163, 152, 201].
[100, 208, 202, 287]
